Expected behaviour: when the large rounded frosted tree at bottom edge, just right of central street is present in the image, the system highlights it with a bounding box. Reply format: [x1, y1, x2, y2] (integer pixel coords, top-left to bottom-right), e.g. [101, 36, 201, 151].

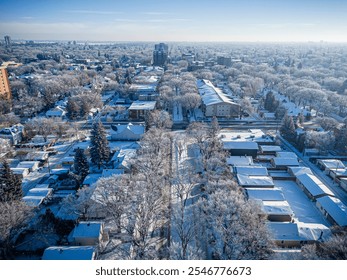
[207, 188, 273, 260]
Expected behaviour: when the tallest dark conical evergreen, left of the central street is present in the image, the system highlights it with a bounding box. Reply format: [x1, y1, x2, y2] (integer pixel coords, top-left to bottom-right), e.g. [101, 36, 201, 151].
[90, 121, 110, 169]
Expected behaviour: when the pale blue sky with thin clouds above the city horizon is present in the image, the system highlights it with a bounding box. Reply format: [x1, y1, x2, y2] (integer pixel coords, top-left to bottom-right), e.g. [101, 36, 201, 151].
[0, 0, 347, 42]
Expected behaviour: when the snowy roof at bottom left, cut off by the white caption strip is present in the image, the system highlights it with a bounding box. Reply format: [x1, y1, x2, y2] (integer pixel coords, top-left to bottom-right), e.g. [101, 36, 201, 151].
[42, 246, 95, 260]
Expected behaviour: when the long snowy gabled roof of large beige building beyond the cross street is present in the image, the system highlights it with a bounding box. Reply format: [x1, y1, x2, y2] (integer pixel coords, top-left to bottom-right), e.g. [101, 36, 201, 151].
[197, 79, 240, 106]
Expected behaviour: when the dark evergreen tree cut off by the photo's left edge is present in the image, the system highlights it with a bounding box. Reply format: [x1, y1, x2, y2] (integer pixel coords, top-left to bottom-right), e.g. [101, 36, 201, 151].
[0, 160, 23, 202]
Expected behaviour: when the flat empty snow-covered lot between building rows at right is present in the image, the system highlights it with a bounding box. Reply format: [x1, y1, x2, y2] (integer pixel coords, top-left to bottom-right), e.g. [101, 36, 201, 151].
[274, 180, 330, 226]
